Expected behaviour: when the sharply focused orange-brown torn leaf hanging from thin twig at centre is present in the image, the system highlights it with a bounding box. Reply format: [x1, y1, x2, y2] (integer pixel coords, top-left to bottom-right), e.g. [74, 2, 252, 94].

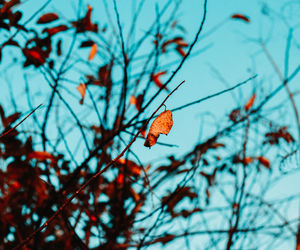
[144, 110, 173, 148]
